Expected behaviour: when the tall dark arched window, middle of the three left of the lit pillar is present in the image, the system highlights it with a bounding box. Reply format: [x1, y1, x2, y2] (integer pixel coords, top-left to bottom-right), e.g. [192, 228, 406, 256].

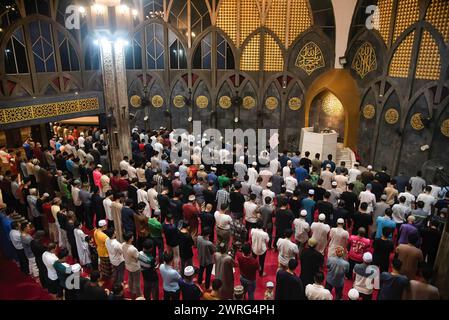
[29, 21, 56, 72]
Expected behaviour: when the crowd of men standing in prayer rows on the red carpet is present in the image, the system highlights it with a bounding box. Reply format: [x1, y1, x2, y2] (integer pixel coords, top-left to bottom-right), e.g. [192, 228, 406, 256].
[0, 124, 449, 300]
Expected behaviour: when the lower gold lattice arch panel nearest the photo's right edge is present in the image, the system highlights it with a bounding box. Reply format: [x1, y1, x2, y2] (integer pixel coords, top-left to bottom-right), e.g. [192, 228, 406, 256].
[415, 30, 441, 80]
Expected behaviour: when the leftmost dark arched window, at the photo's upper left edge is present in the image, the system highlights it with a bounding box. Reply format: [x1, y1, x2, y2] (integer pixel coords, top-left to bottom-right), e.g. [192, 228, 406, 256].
[5, 27, 29, 74]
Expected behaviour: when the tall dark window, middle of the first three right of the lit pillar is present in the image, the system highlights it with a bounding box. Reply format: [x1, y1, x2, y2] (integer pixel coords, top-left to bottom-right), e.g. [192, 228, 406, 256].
[145, 23, 164, 69]
